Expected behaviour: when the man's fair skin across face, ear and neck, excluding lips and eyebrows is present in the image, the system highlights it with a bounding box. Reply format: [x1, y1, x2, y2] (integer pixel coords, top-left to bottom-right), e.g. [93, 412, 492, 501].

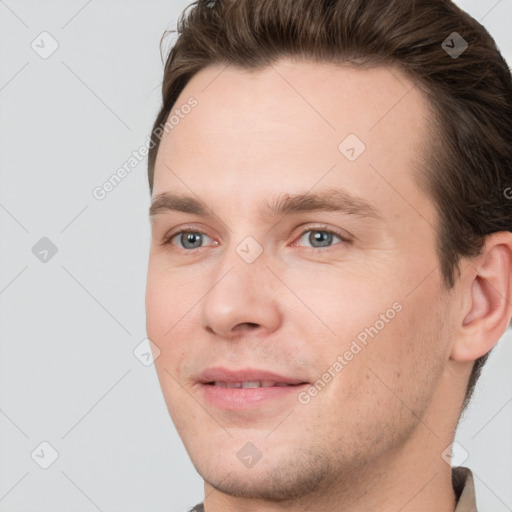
[146, 59, 512, 512]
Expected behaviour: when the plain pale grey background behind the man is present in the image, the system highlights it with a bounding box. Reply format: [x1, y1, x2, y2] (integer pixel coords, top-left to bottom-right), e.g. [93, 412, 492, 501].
[0, 0, 512, 512]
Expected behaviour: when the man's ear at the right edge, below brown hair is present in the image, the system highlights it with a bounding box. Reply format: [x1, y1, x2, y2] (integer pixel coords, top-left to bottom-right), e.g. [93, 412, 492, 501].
[450, 231, 512, 362]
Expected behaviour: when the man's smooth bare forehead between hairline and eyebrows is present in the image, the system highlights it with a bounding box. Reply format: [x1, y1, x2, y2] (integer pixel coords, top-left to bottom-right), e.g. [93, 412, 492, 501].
[153, 59, 434, 229]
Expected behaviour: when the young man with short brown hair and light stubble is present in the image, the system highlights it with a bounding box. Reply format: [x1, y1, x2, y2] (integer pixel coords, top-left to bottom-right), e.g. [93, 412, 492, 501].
[146, 0, 512, 512]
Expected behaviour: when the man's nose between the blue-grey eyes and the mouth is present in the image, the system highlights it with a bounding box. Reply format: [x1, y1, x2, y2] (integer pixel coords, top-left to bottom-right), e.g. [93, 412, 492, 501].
[201, 245, 282, 339]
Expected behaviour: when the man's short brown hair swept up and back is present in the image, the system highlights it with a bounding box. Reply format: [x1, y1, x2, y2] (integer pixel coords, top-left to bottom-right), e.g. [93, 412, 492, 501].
[148, 0, 512, 408]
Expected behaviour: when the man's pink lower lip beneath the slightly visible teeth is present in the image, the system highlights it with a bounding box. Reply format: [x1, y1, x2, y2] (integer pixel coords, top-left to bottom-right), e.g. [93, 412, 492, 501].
[201, 384, 307, 410]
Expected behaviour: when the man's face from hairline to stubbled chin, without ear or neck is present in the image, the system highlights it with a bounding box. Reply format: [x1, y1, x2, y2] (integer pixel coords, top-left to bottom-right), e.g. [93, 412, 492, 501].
[146, 61, 450, 498]
